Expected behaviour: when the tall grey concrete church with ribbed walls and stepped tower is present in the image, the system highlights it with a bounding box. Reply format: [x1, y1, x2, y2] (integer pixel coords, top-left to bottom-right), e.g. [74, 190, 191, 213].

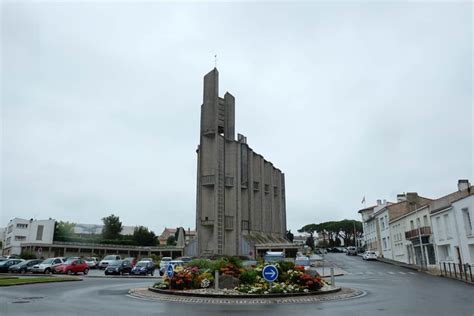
[196, 68, 286, 256]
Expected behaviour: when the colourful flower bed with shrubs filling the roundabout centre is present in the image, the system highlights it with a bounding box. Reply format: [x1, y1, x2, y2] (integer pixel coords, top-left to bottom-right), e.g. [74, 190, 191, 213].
[154, 258, 325, 294]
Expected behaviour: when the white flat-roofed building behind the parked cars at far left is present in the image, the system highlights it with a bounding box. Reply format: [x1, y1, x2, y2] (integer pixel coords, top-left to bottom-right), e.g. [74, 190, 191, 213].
[2, 218, 55, 255]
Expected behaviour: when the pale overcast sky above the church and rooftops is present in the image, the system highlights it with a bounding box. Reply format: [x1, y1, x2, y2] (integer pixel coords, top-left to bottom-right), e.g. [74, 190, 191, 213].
[0, 1, 474, 233]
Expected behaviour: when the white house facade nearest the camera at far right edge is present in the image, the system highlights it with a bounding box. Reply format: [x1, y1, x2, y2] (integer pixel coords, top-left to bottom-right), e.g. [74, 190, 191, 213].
[431, 194, 474, 265]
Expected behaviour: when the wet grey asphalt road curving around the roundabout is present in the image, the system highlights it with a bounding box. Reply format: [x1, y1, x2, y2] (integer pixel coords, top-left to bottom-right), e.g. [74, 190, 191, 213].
[0, 254, 474, 316]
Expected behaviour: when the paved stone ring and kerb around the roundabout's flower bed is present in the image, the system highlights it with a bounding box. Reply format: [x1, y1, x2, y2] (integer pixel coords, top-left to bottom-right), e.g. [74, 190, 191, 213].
[128, 287, 366, 304]
